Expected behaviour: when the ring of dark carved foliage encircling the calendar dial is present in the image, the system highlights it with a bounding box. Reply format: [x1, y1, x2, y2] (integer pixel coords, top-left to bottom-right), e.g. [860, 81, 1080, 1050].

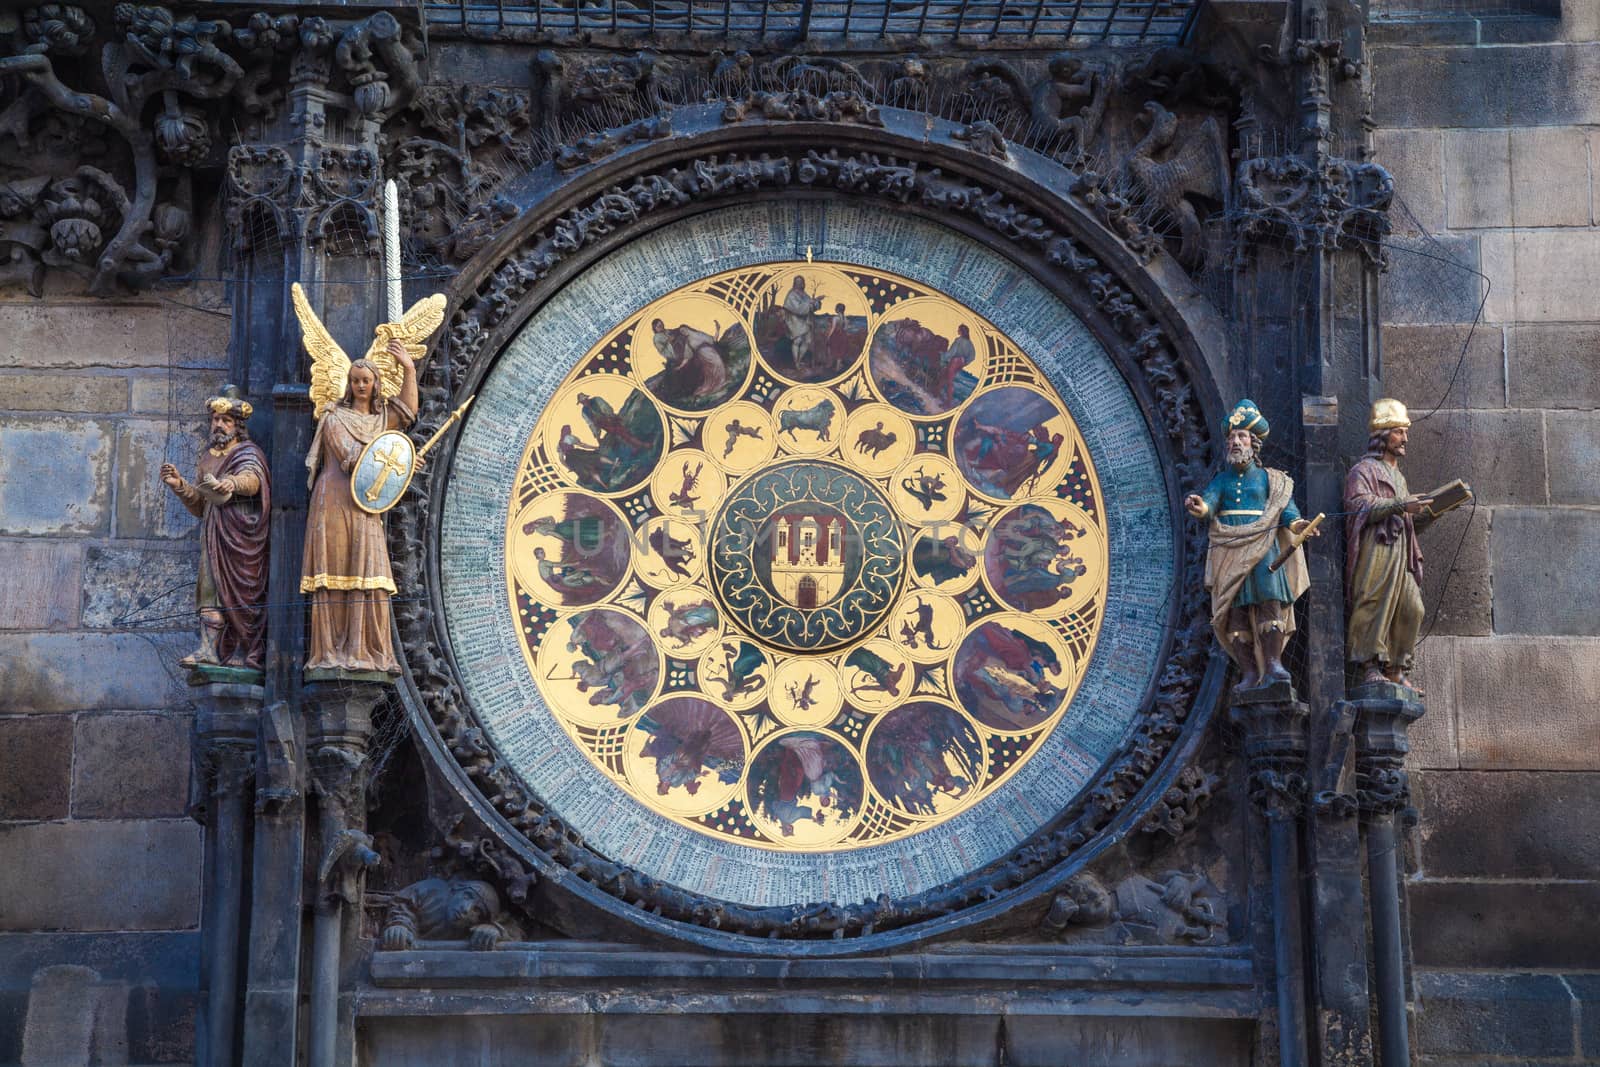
[390, 150, 1210, 937]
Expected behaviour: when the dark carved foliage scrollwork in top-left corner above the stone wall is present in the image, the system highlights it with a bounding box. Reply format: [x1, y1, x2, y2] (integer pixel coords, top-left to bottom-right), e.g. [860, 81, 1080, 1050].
[0, 3, 232, 294]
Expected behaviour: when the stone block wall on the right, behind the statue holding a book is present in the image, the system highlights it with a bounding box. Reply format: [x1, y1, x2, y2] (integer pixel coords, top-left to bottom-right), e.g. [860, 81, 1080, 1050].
[1371, 0, 1600, 1064]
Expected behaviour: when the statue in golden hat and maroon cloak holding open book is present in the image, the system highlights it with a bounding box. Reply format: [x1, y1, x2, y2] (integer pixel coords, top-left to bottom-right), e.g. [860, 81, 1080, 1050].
[1344, 400, 1472, 689]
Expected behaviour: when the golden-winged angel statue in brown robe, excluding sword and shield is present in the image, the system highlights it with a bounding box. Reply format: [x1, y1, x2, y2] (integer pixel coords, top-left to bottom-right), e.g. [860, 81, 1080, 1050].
[291, 283, 445, 677]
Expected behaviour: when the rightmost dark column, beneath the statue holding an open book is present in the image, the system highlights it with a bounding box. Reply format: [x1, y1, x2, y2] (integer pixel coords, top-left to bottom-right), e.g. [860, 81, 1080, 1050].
[1350, 683, 1426, 1067]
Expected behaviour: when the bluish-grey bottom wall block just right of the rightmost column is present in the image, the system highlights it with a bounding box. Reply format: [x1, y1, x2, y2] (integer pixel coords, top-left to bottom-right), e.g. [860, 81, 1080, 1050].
[1416, 971, 1576, 1062]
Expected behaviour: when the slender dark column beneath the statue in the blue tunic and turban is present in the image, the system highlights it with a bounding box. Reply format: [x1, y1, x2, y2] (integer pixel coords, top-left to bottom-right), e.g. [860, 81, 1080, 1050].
[1229, 685, 1310, 1067]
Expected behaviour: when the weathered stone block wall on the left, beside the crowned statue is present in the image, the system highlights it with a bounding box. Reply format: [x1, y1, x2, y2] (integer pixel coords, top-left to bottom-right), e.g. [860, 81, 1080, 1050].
[0, 278, 229, 1064]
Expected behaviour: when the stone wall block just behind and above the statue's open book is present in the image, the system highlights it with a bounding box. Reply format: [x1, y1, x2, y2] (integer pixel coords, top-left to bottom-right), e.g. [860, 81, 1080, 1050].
[1402, 408, 1547, 508]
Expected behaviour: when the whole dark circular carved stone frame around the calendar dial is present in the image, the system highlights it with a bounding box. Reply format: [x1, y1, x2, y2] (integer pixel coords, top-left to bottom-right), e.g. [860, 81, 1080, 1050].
[390, 109, 1226, 955]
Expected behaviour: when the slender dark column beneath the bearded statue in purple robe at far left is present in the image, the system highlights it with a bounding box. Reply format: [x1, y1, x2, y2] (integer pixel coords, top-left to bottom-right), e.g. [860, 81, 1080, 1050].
[190, 683, 267, 1067]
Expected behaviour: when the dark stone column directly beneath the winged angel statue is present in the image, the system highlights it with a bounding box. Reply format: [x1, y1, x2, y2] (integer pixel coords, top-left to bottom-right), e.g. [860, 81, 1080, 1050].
[304, 681, 389, 1067]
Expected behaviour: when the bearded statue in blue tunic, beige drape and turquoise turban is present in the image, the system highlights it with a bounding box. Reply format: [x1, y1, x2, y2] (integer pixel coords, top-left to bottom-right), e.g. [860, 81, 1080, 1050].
[1184, 400, 1318, 689]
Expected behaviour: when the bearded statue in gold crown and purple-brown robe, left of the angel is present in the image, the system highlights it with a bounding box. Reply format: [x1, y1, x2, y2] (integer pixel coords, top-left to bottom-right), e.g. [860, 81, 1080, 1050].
[162, 386, 272, 670]
